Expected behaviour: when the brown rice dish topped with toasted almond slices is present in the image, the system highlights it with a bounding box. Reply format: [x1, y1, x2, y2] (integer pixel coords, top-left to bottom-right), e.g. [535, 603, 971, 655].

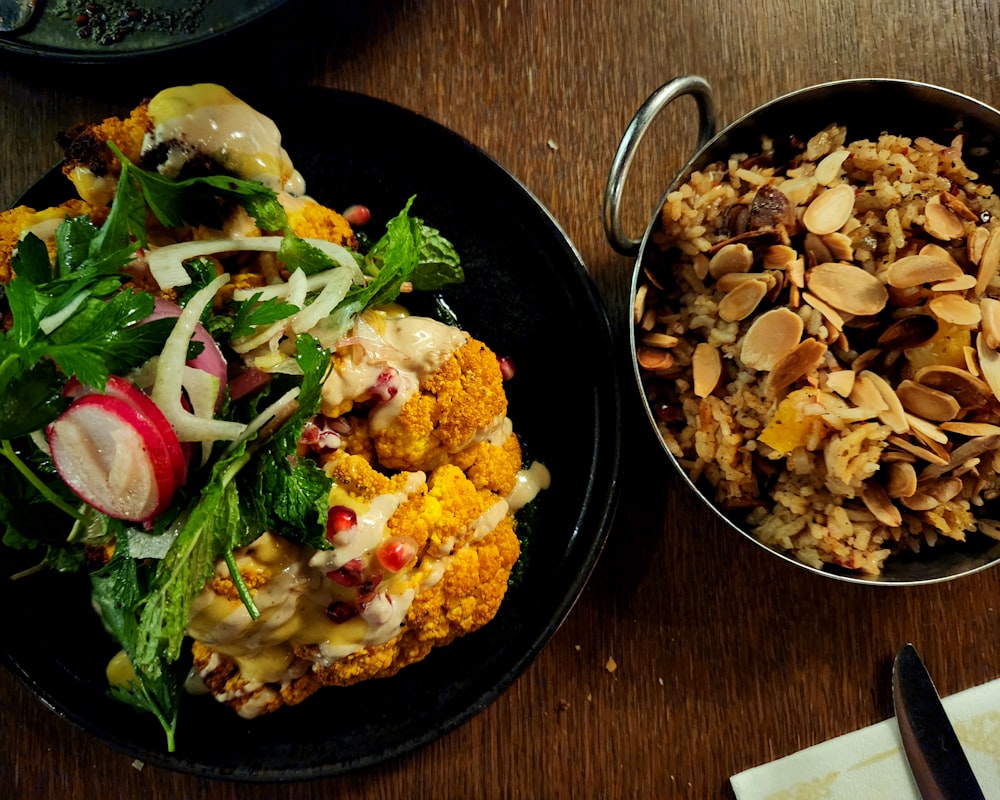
[635, 125, 1000, 575]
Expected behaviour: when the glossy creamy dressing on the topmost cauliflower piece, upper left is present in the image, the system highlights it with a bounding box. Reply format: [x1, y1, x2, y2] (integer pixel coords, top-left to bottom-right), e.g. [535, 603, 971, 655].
[143, 83, 305, 195]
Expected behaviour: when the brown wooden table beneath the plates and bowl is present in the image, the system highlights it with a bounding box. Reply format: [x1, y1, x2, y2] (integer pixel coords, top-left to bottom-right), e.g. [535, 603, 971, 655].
[0, 0, 1000, 800]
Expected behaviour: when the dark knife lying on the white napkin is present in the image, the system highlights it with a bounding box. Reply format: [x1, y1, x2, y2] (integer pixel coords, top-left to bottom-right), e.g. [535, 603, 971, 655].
[892, 644, 985, 800]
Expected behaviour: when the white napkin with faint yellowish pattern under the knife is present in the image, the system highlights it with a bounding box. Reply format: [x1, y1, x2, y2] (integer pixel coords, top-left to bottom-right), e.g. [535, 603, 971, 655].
[730, 680, 1000, 800]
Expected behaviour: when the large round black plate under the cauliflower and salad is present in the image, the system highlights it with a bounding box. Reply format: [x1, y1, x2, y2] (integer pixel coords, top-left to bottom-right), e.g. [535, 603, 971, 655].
[0, 88, 619, 781]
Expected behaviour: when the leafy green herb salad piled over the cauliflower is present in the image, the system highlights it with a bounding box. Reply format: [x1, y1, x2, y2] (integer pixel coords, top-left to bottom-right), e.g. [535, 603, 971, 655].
[0, 146, 463, 750]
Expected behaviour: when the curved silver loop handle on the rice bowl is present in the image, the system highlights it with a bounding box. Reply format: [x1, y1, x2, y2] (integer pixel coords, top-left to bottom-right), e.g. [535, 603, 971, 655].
[604, 75, 716, 256]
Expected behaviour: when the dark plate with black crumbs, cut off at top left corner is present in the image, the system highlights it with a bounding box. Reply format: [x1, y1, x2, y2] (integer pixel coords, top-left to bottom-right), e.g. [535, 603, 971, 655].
[0, 0, 287, 61]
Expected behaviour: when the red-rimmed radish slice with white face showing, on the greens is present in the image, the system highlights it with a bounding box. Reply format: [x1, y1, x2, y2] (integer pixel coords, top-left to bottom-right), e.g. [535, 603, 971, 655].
[46, 394, 177, 522]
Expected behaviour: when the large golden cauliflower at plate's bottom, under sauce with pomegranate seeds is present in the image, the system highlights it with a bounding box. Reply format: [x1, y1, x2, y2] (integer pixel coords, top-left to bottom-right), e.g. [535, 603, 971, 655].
[186, 455, 520, 717]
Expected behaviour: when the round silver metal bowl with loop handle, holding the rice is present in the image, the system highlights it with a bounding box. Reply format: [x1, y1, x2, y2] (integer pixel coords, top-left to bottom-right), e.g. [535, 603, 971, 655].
[604, 76, 1000, 586]
